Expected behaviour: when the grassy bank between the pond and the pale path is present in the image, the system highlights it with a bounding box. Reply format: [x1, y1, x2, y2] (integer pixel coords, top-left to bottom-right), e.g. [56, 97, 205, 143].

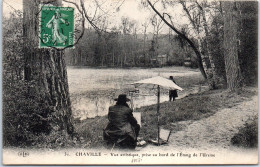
[75, 89, 257, 148]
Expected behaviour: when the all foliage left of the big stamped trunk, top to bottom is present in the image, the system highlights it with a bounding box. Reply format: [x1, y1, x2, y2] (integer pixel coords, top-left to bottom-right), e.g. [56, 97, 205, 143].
[3, 12, 71, 147]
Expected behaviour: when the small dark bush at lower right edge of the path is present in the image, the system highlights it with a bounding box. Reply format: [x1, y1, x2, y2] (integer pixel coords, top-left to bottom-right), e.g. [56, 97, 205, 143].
[231, 116, 258, 148]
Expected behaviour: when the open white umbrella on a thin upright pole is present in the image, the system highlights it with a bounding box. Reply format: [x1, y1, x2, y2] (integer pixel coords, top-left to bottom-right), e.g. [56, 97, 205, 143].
[132, 76, 183, 145]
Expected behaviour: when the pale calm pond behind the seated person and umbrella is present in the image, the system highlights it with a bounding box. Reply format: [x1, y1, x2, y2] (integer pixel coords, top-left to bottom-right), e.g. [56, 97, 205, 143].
[68, 67, 207, 120]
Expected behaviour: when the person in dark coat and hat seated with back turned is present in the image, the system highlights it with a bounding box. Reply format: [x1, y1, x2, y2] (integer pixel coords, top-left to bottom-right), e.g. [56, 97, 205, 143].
[104, 94, 140, 149]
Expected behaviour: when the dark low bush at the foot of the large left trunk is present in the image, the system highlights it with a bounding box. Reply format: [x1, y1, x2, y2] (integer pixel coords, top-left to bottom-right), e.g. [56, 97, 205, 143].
[3, 80, 50, 147]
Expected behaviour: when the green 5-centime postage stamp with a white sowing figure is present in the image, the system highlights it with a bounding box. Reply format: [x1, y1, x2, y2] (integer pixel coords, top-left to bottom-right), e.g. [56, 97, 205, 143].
[39, 6, 74, 48]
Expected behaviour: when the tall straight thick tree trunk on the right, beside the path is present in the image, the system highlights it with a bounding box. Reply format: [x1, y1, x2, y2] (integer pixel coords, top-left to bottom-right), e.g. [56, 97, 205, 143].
[223, 1, 241, 91]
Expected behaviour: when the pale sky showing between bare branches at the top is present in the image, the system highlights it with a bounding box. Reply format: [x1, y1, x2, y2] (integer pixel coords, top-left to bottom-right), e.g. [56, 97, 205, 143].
[2, 0, 187, 33]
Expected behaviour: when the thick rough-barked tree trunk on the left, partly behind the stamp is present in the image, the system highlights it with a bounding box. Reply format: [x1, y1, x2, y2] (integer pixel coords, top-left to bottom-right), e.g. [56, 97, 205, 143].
[23, 0, 73, 134]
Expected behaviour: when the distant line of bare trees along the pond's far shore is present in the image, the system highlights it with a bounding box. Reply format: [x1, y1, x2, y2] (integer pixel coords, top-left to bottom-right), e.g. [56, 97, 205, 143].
[65, 29, 197, 67]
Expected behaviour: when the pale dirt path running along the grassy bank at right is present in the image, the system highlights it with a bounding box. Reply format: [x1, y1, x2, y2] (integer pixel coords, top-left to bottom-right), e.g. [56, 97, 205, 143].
[140, 96, 258, 151]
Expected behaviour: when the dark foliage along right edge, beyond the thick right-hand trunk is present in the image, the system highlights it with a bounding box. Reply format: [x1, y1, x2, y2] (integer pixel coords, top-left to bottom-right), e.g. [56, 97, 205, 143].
[238, 1, 258, 86]
